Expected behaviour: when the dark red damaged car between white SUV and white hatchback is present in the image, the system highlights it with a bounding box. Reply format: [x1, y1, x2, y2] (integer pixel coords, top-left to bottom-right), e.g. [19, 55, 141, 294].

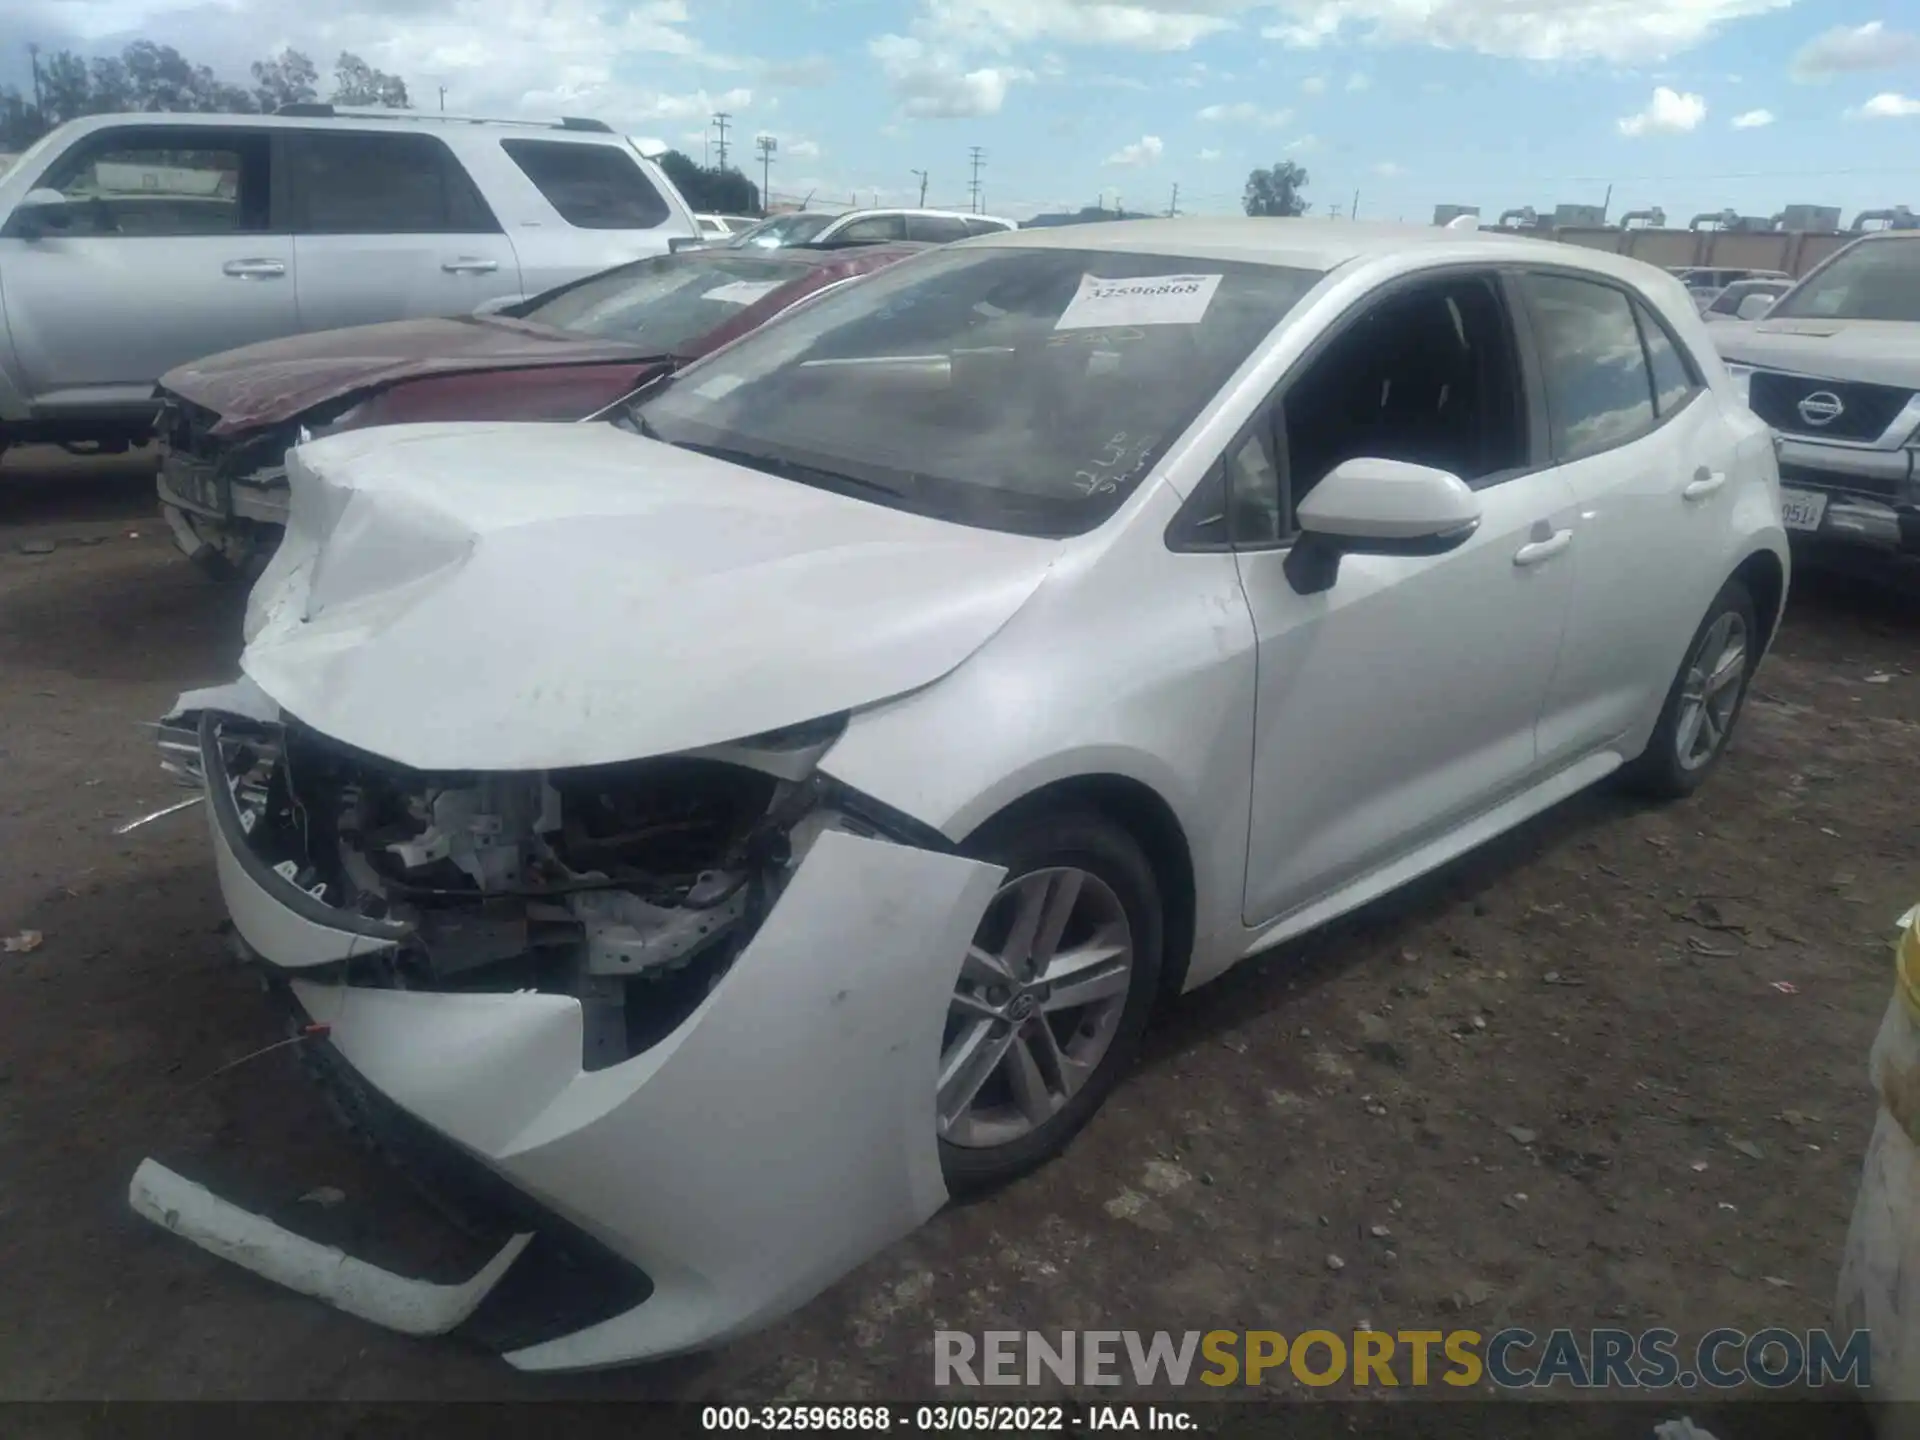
[156, 244, 929, 578]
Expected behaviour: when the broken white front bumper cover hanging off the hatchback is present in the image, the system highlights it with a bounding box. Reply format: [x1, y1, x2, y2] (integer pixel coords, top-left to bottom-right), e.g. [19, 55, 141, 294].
[167, 720, 1002, 1371]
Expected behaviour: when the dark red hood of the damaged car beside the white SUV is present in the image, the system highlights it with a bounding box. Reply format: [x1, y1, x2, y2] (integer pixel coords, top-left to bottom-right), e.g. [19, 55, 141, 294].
[159, 315, 668, 434]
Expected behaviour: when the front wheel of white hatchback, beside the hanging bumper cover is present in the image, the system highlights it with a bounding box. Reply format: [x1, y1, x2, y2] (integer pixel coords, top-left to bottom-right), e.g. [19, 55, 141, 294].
[937, 808, 1165, 1194]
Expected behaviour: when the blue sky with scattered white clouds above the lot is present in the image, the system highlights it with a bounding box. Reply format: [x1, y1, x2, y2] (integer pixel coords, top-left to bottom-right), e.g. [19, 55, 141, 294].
[0, 0, 1920, 225]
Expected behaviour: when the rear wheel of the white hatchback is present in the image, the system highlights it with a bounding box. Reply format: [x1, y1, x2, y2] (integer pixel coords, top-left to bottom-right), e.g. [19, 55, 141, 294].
[1620, 580, 1761, 801]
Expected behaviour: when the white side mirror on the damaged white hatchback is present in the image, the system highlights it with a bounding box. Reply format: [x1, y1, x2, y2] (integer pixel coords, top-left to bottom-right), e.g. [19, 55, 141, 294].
[1284, 457, 1480, 595]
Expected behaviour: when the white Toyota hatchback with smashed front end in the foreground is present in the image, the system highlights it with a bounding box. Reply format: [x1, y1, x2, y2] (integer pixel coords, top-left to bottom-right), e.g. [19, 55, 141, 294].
[145, 219, 1788, 1369]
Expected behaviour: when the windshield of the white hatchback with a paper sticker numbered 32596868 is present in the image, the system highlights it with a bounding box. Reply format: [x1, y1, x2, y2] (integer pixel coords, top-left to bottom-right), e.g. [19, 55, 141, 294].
[630, 248, 1319, 536]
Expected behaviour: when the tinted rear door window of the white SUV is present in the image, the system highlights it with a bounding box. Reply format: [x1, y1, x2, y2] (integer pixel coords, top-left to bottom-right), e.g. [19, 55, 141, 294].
[286, 131, 499, 234]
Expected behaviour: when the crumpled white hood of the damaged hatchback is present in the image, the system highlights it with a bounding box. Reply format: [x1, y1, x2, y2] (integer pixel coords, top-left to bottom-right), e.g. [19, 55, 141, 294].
[240, 424, 1060, 770]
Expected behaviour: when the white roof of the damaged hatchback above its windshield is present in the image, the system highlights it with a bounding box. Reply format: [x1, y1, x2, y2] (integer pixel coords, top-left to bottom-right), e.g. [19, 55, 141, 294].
[966, 217, 1659, 278]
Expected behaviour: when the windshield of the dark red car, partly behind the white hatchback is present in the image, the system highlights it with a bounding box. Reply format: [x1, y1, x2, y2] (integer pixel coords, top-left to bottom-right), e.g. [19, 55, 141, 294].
[509, 250, 812, 355]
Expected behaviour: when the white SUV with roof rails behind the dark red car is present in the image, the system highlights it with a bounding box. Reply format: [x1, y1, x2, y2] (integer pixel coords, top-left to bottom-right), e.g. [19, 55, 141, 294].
[0, 104, 699, 462]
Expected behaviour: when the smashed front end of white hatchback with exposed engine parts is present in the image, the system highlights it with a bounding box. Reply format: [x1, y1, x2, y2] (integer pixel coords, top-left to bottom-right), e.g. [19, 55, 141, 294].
[136, 695, 1000, 1369]
